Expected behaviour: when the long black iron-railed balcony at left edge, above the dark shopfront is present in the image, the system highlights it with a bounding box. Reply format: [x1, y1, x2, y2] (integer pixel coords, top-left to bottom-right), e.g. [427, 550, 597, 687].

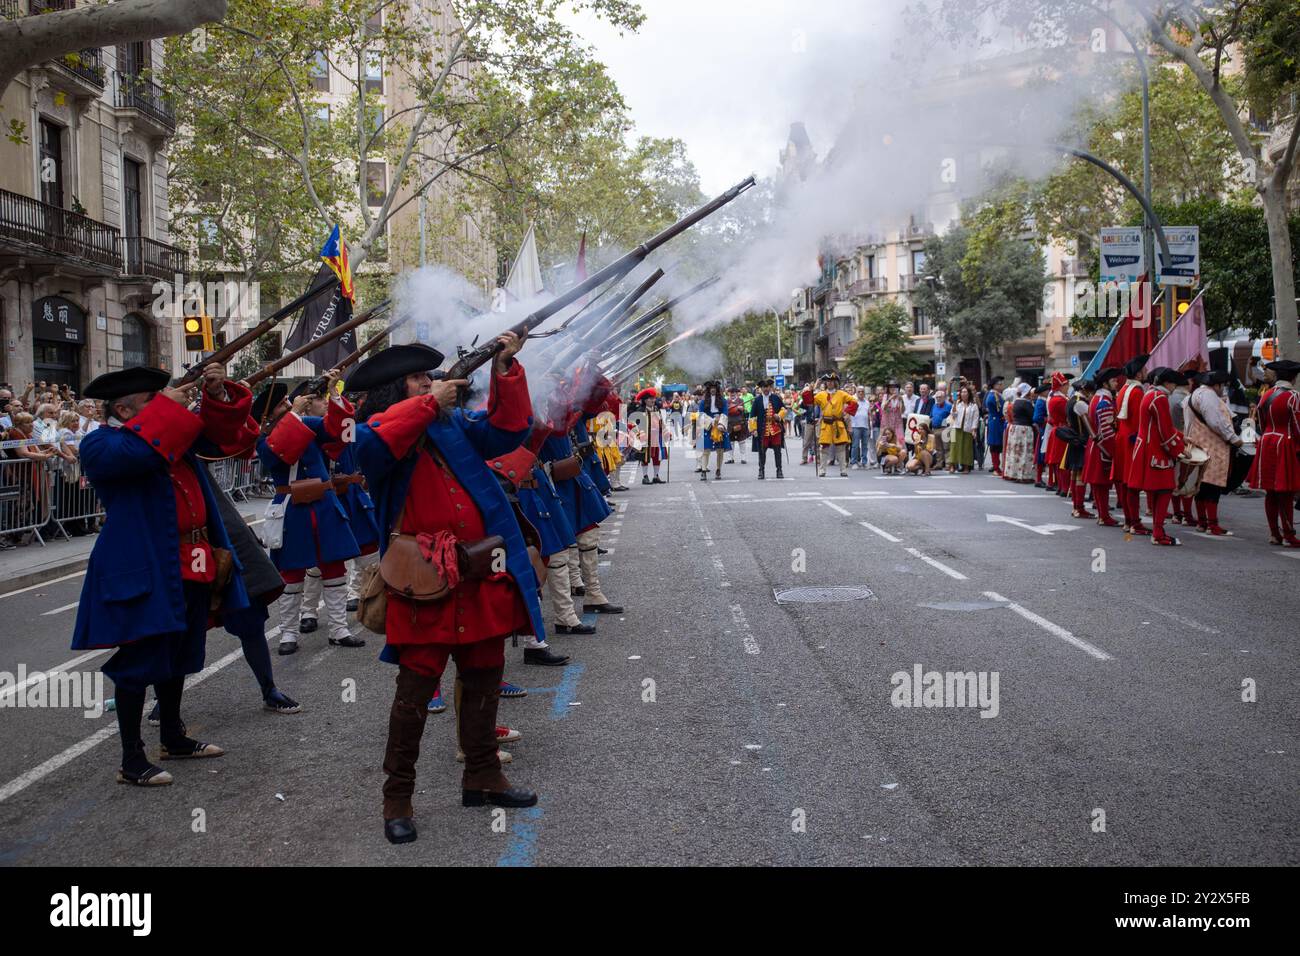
[0, 190, 122, 274]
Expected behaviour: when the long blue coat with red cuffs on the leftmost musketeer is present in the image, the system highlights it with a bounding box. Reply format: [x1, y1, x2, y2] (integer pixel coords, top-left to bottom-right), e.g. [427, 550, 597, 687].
[72, 382, 252, 650]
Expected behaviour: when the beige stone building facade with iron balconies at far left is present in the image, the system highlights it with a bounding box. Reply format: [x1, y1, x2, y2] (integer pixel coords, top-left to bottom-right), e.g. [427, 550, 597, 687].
[0, 0, 189, 392]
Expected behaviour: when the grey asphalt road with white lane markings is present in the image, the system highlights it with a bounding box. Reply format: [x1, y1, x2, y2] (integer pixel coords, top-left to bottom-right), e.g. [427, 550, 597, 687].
[0, 450, 1300, 865]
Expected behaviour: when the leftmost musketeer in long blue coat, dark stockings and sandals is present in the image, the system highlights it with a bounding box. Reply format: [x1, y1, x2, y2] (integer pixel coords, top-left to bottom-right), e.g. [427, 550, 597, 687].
[73, 363, 251, 786]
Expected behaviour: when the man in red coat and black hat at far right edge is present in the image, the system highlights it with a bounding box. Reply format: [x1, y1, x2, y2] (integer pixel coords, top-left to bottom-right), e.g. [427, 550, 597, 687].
[1249, 359, 1300, 548]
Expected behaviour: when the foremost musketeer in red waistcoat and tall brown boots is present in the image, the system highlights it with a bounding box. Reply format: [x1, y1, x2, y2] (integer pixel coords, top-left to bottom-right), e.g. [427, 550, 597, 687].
[348, 332, 542, 843]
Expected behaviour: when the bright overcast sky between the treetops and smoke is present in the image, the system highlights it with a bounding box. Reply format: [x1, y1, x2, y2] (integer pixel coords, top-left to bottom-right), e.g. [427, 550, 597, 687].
[566, 0, 902, 194]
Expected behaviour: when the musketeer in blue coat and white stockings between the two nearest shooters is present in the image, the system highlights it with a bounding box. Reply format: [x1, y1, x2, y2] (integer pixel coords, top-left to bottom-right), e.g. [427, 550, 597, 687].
[252, 369, 365, 654]
